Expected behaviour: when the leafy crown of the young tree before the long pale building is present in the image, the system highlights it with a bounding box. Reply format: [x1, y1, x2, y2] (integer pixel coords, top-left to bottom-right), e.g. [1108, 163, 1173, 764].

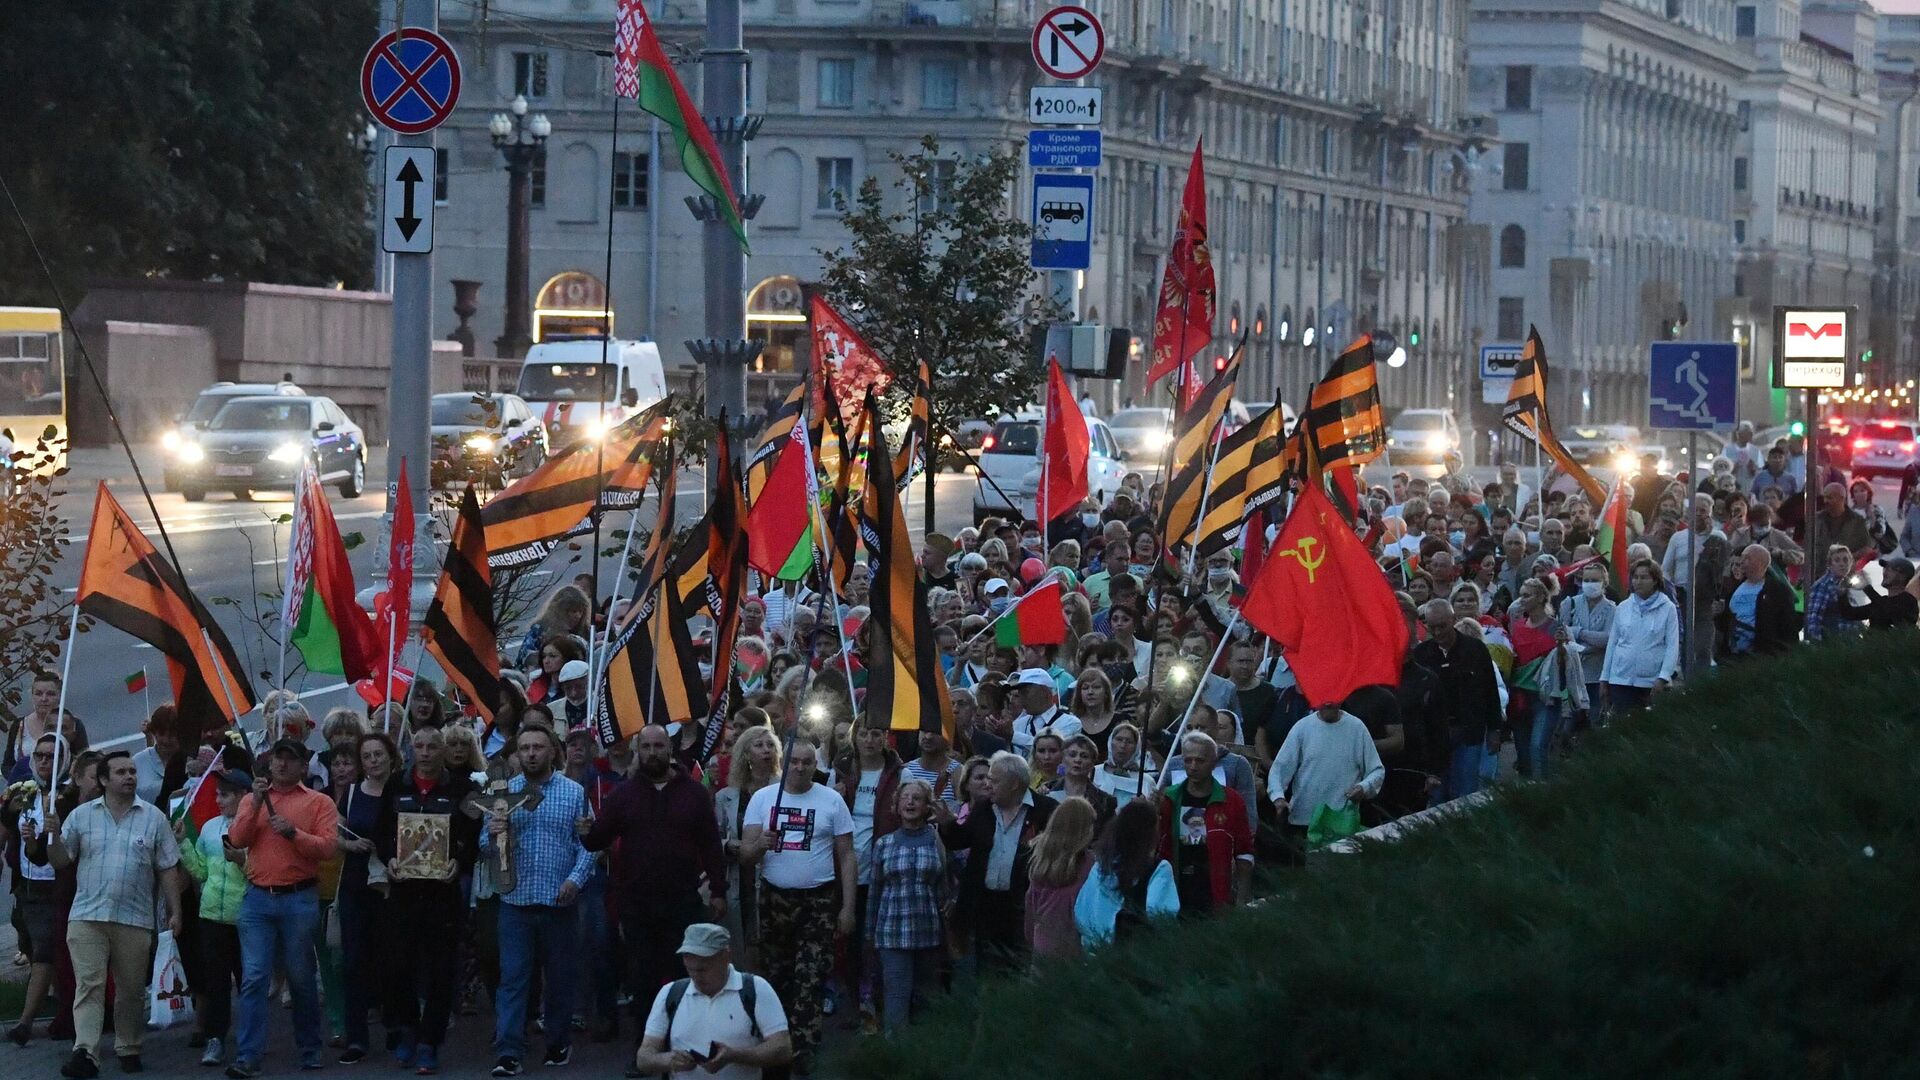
[820, 135, 1060, 430]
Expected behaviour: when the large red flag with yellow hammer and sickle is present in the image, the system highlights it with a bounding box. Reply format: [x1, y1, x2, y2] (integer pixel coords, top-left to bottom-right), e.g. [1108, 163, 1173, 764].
[1240, 484, 1407, 707]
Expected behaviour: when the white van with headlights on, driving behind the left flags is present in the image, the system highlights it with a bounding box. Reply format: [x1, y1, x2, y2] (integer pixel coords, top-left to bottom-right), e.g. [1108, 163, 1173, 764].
[515, 338, 666, 441]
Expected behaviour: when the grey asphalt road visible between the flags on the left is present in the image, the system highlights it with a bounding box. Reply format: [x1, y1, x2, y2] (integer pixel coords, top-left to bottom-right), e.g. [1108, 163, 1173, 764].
[33, 450, 973, 746]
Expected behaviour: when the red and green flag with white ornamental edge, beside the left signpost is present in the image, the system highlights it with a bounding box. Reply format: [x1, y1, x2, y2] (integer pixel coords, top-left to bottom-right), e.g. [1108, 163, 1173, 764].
[282, 473, 382, 682]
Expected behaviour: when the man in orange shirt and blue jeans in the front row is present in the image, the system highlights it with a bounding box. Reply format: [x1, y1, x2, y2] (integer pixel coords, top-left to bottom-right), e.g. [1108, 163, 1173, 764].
[227, 738, 340, 1080]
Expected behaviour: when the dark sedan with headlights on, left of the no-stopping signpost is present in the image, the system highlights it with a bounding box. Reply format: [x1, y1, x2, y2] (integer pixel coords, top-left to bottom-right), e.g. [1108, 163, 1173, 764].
[177, 396, 367, 502]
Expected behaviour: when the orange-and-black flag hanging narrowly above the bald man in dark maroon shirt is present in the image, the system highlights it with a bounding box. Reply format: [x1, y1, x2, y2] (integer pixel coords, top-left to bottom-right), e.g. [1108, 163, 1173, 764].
[593, 445, 707, 746]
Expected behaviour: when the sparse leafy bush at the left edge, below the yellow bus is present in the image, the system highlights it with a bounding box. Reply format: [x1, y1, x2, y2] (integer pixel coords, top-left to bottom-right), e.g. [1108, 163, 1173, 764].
[0, 429, 73, 721]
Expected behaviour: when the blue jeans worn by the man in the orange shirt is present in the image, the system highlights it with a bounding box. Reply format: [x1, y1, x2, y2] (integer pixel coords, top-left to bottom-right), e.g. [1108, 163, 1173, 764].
[234, 888, 324, 1063]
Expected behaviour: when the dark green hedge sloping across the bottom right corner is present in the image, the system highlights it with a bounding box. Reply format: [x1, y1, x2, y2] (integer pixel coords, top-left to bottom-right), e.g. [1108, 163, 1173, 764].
[824, 634, 1920, 1080]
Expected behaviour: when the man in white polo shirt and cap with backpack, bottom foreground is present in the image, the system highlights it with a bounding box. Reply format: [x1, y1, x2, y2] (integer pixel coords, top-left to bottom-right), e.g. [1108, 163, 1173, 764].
[634, 922, 793, 1080]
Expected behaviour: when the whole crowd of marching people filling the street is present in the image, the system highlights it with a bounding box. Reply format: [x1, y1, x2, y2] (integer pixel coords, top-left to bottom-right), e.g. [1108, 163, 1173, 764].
[0, 413, 1920, 1080]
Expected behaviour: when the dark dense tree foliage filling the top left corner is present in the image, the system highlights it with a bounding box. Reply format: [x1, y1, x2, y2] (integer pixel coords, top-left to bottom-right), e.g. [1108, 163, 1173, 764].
[0, 0, 376, 304]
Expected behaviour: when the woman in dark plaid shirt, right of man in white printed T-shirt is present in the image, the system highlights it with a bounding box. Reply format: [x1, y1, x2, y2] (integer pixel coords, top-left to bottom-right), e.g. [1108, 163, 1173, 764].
[866, 780, 952, 1032]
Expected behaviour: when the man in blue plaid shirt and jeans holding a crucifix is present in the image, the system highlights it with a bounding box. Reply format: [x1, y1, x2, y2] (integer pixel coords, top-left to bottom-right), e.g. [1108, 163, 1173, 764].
[480, 724, 593, 1076]
